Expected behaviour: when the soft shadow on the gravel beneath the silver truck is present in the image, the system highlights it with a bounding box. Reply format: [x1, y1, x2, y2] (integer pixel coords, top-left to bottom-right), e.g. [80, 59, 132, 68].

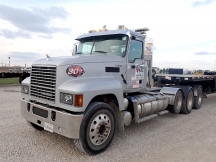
[34, 113, 181, 156]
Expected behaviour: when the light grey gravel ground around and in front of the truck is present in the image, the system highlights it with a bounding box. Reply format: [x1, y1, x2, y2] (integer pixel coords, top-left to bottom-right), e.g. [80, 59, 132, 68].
[0, 86, 216, 162]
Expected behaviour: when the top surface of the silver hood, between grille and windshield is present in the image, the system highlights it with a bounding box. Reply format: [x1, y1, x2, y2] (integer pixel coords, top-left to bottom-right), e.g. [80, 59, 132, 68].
[33, 54, 123, 66]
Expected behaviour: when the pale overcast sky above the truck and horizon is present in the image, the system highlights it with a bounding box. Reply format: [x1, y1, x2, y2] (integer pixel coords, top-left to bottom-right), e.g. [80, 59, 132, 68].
[0, 0, 216, 70]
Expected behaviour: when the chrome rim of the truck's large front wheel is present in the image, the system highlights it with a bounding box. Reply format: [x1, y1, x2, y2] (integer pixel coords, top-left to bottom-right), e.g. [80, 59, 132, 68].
[89, 114, 111, 145]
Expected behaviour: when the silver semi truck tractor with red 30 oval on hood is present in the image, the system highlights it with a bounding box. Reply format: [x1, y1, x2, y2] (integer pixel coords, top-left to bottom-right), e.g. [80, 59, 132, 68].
[20, 25, 214, 155]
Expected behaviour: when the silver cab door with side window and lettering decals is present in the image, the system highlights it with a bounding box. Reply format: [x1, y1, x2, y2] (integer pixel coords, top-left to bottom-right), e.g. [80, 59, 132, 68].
[127, 36, 147, 92]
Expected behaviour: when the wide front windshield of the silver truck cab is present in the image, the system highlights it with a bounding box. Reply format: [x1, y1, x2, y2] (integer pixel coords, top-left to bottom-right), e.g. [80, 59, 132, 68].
[77, 34, 128, 57]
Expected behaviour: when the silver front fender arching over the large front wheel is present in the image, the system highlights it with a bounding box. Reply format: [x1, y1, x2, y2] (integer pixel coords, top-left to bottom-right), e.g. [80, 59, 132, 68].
[58, 76, 124, 111]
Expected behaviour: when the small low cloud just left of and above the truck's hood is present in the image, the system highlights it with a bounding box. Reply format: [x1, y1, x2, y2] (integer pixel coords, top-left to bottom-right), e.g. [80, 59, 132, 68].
[8, 51, 41, 61]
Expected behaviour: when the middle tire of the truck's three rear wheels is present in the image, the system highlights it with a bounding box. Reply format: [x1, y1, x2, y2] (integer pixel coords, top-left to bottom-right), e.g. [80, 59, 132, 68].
[181, 87, 194, 114]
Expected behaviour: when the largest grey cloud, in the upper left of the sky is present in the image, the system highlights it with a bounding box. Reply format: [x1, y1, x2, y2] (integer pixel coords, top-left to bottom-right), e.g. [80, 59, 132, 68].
[0, 4, 71, 34]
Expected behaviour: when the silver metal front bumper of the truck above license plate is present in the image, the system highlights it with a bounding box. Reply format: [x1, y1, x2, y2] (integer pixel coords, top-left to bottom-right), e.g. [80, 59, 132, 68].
[21, 100, 83, 139]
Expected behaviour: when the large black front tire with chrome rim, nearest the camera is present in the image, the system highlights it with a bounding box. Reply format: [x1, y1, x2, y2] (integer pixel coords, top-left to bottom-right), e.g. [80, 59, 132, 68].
[74, 102, 116, 155]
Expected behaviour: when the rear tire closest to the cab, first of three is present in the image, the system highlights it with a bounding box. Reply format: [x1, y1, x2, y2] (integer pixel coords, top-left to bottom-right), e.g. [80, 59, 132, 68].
[168, 90, 183, 114]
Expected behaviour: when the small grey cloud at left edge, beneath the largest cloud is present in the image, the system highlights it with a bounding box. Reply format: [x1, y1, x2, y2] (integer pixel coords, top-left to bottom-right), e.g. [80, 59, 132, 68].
[0, 29, 31, 39]
